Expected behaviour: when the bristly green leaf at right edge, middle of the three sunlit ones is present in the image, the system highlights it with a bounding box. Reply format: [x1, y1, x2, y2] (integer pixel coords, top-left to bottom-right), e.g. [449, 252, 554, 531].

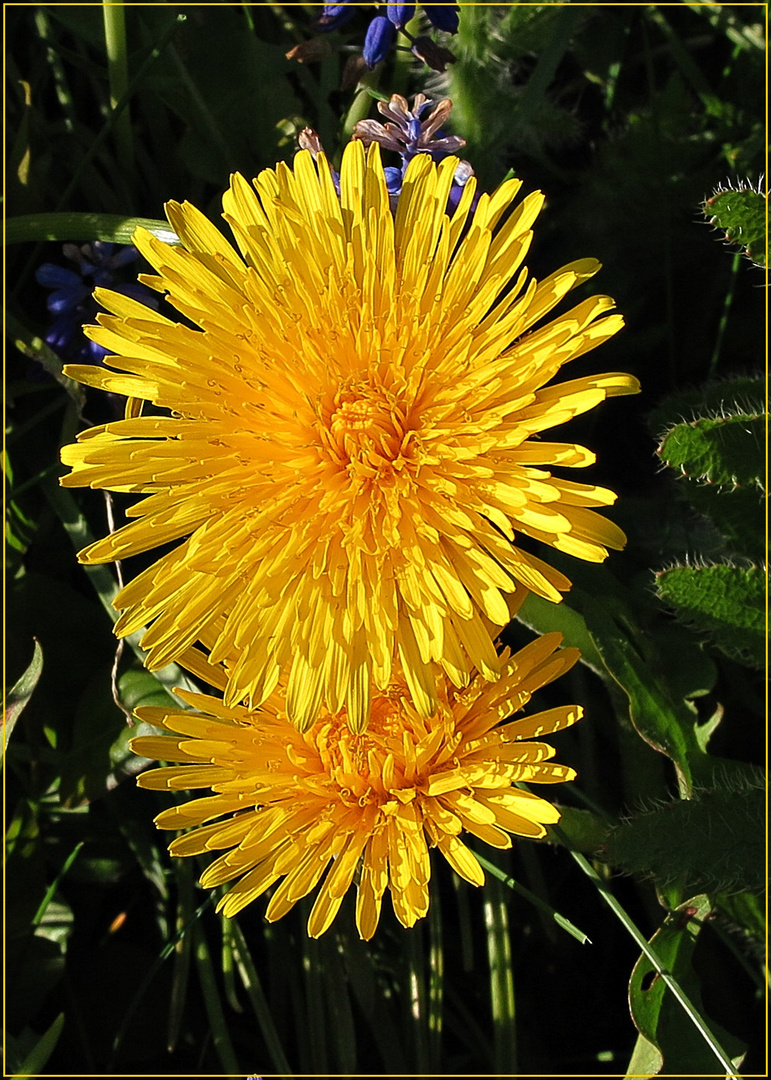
[657, 414, 767, 490]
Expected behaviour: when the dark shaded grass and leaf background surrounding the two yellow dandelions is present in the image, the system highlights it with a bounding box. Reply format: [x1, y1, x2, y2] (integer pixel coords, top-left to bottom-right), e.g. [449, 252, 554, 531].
[4, 3, 766, 1076]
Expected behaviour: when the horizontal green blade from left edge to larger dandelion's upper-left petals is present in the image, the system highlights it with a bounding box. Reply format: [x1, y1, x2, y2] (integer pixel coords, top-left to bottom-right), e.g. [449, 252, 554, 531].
[5, 212, 180, 244]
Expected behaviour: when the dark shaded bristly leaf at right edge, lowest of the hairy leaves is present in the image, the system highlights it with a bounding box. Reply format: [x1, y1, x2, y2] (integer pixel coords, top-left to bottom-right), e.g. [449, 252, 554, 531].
[604, 767, 766, 893]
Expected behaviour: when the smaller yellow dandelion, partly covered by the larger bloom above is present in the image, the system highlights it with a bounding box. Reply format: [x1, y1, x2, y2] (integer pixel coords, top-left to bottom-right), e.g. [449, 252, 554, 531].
[132, 634, 581, 939]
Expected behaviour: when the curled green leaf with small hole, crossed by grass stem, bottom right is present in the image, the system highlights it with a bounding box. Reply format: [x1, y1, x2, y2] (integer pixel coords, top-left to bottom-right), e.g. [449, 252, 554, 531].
[627, 895, 746, 1077]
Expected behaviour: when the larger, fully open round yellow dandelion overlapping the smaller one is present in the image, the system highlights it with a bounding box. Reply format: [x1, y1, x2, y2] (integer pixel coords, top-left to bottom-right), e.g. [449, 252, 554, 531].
[62, 135, 637, 730]
